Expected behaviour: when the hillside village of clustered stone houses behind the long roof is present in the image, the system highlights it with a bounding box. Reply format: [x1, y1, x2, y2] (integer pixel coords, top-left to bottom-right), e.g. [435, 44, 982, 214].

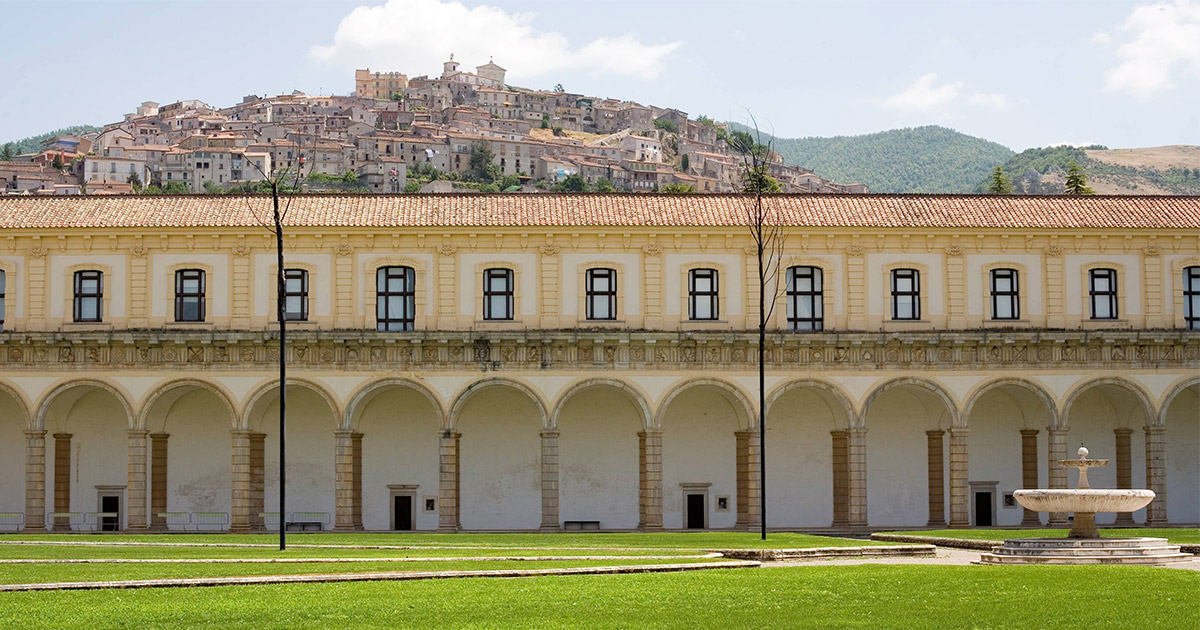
[0, 55, 866, 194]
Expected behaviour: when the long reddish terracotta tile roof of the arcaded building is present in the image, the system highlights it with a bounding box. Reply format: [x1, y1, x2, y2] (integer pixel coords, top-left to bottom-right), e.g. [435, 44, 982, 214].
[0, 193, 1200, 230]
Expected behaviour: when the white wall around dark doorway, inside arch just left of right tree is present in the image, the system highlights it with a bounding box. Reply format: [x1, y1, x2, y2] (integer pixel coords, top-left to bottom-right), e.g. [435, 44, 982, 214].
[662, 386, 738, 529]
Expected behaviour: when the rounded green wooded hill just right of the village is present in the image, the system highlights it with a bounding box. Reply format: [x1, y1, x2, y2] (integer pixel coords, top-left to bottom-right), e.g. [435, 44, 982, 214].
[731, 124, 1013, 192]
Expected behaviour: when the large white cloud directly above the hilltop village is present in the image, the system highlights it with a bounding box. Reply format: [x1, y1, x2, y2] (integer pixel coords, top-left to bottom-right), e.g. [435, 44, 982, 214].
[310, 0, 683, 80]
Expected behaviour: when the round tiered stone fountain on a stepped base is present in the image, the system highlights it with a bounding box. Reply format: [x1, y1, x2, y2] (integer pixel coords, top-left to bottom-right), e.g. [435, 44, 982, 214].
[979, 446, 1194, 565]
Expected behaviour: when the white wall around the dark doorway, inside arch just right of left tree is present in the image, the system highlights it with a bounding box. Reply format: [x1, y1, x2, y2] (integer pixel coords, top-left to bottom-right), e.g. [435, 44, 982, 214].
[355, 386, 439, 530]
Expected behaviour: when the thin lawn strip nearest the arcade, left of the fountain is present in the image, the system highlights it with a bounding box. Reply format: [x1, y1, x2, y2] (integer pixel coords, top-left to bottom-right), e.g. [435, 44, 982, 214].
[0, 532, 880, 550]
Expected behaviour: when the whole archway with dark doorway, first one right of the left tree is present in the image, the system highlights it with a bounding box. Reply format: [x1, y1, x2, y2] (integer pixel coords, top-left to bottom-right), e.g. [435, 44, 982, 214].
[348, 380, 442, 530]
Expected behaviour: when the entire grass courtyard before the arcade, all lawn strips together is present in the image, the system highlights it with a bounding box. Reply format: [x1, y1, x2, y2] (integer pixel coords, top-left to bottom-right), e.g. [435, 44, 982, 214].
[0, 530, 1200, 630]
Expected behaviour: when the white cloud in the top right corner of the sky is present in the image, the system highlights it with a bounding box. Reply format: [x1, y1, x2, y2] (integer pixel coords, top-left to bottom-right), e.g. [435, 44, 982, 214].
[1104, 0, 1200, 101]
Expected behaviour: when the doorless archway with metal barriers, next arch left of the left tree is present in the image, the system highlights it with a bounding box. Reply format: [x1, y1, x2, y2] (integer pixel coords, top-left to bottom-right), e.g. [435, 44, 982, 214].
[139, 380, 235, 529]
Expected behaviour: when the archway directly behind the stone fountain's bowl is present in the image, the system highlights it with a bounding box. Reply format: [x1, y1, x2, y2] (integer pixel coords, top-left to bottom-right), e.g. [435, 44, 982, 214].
[1063, 379, 1152, 524]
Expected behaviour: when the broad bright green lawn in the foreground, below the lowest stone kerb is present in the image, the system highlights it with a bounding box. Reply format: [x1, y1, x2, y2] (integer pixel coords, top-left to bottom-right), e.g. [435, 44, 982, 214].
[0, 565, 1200, 630]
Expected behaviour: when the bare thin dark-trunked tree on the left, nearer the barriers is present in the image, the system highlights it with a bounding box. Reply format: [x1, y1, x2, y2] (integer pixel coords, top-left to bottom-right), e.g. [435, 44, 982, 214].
[246, 151, 305, 551]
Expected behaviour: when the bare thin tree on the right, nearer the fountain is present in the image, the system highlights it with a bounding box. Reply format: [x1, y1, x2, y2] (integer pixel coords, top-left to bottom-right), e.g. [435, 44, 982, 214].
[728, 115, 786, 540]
